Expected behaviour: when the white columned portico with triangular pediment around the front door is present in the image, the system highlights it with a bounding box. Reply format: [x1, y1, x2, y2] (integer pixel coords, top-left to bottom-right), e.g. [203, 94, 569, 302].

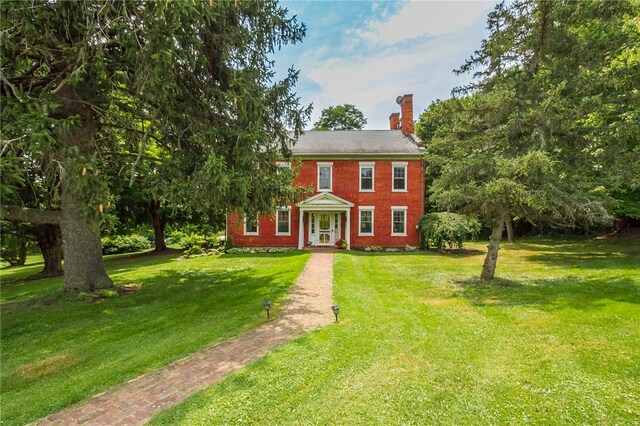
[296, 192, 354, 249]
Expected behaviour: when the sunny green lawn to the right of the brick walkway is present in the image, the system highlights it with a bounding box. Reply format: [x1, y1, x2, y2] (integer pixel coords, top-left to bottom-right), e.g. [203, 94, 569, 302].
[153, 239, 640, 425]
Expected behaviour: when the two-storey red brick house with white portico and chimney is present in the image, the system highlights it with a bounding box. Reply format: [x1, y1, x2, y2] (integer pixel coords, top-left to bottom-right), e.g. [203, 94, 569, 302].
[227, 95, 424, 249]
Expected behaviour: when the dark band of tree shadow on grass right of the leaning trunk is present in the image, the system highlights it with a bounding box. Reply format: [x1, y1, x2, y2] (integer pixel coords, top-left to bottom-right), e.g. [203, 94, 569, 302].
[456, 276, 640, 311]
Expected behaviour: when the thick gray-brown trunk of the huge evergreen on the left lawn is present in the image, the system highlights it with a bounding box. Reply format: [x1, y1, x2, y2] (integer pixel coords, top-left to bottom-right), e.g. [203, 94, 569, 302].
[58, 83, 113, 291]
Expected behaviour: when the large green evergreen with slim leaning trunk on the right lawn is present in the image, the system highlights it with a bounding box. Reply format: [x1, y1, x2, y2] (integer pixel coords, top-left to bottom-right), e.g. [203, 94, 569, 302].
[427, 0, 640, 280]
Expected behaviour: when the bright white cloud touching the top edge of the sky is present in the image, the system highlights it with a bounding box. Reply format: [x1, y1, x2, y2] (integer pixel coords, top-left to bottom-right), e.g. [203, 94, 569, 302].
[354, 1, 493, 45]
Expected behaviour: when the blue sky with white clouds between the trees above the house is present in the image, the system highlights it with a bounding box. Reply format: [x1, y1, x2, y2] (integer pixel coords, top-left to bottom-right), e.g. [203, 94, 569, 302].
[275, 1, 496, 129]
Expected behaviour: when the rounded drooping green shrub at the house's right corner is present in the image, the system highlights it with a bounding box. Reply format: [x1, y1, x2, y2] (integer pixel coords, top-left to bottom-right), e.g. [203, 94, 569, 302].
[420, 213, 480, 249]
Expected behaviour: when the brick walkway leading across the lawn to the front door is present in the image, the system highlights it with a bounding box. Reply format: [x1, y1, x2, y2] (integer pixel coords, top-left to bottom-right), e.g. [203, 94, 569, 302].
[38, 253, 333, 425]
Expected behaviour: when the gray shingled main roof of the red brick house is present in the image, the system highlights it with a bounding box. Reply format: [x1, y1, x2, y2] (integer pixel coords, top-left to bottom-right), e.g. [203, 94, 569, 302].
[293, 130, 422, 156]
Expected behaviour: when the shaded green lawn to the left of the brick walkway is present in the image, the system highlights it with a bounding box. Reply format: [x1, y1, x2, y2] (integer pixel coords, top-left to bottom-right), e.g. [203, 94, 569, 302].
[0, 254, 308, 424]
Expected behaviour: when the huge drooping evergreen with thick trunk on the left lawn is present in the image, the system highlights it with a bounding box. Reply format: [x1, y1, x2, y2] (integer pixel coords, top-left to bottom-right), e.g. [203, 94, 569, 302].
[0, 1, 309, 291]
